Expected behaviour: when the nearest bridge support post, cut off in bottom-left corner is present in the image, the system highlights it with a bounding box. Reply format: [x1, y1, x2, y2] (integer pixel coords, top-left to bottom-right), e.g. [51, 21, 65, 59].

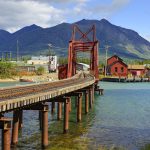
[0, 117, 11, 150]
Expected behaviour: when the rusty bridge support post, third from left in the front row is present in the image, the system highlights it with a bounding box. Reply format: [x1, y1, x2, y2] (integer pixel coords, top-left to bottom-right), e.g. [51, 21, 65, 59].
[64, 97, 70, 133]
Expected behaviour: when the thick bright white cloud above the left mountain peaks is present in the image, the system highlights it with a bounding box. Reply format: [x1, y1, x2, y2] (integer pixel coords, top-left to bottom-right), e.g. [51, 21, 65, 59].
[0, 0, 64, 31]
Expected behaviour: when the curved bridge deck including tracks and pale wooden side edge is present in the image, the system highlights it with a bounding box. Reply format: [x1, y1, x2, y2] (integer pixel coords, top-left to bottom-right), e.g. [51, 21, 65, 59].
[0, 73, 95, 113]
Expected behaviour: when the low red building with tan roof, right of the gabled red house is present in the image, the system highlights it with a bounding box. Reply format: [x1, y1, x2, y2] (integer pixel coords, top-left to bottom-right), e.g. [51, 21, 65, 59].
[128, 65, 146, 76]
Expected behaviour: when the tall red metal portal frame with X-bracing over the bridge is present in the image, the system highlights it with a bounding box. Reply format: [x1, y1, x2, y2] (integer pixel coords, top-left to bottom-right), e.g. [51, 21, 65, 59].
[67, 25, 99, 81]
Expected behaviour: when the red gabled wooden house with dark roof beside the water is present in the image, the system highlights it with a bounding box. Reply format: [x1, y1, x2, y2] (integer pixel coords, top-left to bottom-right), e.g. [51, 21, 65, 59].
[106, 55, 128, 77]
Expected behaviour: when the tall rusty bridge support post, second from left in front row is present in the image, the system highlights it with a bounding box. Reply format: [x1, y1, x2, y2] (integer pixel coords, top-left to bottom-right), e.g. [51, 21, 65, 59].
[41, 105, 48, 148]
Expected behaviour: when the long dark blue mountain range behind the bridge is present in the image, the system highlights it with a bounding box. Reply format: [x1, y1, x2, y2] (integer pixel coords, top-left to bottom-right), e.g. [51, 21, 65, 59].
[0, 19, 150, 59]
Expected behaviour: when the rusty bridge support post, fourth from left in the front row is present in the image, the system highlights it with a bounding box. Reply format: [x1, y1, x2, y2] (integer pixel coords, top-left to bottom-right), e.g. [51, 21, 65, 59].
[77, 93, 82, 122]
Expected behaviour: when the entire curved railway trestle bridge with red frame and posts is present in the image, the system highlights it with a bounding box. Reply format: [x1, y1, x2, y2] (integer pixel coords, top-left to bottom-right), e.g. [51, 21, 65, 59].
[0, 26, 103, 150]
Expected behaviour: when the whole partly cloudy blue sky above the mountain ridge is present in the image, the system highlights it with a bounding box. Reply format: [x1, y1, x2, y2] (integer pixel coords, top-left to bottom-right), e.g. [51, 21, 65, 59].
[0, 0, 150, 41]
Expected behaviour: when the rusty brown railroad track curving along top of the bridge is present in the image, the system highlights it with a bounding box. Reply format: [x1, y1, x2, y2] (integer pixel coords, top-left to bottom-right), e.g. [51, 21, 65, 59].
[0, 73, 93, 101]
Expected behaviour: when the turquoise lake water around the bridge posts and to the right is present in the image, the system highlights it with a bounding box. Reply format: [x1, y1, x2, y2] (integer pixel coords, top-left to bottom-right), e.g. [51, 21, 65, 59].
[0, 82, 150, 150]
